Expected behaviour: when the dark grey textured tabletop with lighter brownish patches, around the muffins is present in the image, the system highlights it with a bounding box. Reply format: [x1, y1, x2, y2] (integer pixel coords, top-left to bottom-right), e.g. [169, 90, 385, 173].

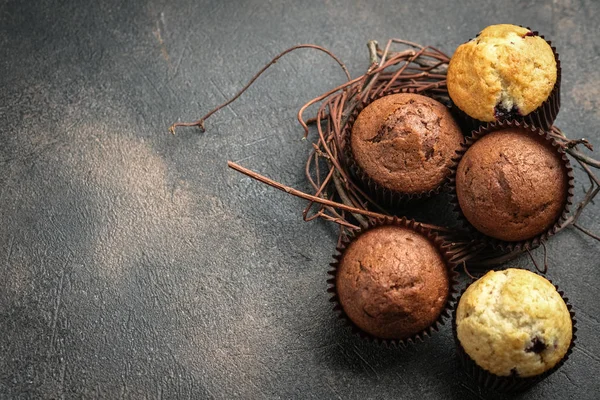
[0, 0, 600, 399]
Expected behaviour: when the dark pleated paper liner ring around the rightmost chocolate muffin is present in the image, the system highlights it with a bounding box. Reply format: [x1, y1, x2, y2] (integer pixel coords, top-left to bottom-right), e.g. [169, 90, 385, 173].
[448, 120, 575, 252]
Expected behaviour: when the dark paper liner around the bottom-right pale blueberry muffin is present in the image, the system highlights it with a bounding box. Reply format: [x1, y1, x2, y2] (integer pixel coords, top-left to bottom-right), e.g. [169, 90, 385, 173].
[452, 274, 577, 393]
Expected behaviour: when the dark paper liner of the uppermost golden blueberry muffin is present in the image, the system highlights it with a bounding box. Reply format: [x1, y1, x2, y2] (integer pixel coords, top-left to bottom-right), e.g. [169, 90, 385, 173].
[454, 28, 562, 131]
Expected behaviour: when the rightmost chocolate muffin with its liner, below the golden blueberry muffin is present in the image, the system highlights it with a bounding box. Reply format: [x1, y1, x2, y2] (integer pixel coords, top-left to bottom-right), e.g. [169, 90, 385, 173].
[449, 121, 574, 251]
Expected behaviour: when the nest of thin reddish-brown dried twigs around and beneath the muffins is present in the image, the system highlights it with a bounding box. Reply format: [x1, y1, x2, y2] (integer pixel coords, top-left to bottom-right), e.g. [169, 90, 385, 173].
[169, 39, 600, 271]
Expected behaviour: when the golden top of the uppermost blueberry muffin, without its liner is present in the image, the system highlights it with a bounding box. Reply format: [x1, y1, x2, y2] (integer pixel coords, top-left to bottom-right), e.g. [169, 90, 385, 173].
[447, 24, 557, 122]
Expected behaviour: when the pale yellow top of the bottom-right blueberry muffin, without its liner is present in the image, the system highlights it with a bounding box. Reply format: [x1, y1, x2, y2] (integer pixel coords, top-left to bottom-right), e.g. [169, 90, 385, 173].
[456, 269, 573, 377]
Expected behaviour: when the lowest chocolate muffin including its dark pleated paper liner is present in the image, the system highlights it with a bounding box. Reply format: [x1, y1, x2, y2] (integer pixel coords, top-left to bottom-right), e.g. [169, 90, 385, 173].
[327, 217, 457, 347]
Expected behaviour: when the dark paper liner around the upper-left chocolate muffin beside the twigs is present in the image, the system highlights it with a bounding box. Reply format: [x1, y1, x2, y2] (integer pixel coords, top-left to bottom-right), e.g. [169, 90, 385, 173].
[342, 89, 464, 207]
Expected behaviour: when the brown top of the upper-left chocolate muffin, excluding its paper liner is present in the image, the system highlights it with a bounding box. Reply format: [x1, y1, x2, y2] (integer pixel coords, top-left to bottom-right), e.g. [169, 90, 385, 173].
[350, 93, 463, 193]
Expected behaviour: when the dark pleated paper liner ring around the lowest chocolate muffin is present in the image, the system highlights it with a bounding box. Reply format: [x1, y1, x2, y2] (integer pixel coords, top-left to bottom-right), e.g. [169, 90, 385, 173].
[327, 217, 458, 348]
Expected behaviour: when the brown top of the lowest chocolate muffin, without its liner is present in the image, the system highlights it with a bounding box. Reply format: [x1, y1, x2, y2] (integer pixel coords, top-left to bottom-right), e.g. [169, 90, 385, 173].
[336, 225, 450, 339]
